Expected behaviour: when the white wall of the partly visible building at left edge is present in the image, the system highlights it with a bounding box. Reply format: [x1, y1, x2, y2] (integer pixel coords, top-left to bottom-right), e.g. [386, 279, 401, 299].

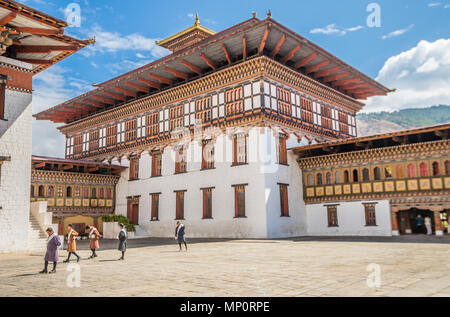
[0, 90, 32, 252]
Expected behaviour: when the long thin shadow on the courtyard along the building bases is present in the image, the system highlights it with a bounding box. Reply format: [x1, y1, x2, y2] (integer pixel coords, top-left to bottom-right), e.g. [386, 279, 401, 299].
[69, 235, 450, 252]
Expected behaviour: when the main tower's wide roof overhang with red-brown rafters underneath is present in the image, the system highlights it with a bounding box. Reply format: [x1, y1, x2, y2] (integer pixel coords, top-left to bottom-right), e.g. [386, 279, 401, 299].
[35, 17, 391, 123]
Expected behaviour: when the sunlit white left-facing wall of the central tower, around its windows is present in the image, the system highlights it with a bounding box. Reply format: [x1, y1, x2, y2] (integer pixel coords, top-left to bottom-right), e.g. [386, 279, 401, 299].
[117, 132, 267, 238]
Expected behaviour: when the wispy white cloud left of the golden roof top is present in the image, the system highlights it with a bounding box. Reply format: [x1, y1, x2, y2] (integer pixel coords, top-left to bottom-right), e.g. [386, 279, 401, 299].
[81, 26, 169, 58]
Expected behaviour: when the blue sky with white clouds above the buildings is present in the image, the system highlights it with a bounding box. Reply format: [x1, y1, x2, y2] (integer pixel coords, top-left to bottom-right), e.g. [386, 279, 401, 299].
[26, 0, 450, 156]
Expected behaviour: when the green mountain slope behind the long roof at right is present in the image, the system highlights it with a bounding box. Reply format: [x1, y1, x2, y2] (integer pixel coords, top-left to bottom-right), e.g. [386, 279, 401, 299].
[357, 105, 450, 136]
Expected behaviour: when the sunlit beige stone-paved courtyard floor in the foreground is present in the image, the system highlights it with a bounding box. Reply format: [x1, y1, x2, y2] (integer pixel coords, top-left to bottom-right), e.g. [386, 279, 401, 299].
[0, 236, 450, 297]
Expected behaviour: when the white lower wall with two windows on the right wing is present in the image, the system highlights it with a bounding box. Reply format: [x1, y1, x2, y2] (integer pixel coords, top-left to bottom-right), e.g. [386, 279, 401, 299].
[306, 200, 392, 236]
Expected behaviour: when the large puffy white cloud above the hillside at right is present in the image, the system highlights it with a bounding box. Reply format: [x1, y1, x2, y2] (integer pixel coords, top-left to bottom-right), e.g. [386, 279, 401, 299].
[364, 38, 450, 111]
